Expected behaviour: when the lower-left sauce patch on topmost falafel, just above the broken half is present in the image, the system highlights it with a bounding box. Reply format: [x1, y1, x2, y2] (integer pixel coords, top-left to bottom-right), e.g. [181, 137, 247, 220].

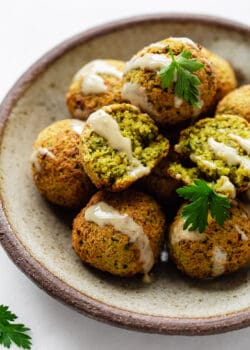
[121, 83, 158, 116]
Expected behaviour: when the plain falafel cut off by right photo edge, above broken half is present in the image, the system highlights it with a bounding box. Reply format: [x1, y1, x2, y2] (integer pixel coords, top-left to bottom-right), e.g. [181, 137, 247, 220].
[216, 85, 250, 122]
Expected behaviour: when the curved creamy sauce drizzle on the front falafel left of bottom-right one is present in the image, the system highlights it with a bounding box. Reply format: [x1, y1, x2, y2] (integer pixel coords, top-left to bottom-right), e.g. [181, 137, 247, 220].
[85, 201, 154, 274]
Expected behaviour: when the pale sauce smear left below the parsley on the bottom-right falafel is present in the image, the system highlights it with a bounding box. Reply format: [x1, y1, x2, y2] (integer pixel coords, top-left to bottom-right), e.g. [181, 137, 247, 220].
[171, 219, 205, 245]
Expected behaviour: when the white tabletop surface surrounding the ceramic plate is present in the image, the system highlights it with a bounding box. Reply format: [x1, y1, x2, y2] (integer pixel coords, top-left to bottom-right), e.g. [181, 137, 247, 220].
[0, 0, 250, 350]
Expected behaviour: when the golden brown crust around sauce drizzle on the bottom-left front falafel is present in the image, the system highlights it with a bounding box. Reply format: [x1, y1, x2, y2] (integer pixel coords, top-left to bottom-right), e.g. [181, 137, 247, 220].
[72, 190, 165, 276]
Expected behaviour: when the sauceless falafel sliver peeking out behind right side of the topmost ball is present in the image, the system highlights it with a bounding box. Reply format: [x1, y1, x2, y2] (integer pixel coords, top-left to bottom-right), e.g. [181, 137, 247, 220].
[201, 47, 237, 104]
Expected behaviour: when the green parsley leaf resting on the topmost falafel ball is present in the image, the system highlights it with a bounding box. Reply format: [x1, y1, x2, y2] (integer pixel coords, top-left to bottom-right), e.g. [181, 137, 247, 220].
[159, 51, 204, 108]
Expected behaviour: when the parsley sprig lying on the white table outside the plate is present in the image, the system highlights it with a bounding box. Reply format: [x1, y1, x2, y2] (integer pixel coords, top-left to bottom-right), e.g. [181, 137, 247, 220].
[0, 305, 32, 349]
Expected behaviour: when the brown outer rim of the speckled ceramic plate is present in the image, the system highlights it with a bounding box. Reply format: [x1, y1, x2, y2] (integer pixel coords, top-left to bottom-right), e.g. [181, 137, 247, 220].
[0, 13, 250, 335]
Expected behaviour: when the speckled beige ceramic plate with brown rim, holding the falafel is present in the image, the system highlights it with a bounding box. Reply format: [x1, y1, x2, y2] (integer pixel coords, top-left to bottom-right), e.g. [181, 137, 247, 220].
[0, 14, 250, 335]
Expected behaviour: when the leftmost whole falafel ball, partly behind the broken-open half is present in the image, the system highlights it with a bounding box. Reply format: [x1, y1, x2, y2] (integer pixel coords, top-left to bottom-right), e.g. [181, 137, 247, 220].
[31, 119, 94, 208]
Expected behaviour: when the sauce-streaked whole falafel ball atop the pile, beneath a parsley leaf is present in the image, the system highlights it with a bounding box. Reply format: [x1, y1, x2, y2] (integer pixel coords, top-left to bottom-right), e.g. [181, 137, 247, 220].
[122, 38, 217, 128]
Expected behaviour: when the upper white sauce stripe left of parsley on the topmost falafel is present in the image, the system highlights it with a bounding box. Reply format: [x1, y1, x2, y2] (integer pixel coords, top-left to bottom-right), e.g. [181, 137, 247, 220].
[124, 53, 172, 73]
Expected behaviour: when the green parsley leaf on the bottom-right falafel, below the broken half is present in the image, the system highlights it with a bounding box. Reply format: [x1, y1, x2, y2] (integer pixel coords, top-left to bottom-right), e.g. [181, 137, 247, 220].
[177, 179, 231, 233]
